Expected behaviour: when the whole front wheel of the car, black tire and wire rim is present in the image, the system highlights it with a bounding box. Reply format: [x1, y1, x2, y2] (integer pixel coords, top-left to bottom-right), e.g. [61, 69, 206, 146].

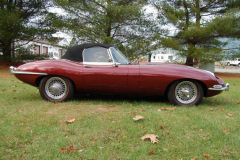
[168, 80, 203, 106]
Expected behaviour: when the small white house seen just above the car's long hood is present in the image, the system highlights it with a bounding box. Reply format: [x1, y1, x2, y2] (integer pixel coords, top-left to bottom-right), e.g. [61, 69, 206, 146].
[151, 48, 177, 62]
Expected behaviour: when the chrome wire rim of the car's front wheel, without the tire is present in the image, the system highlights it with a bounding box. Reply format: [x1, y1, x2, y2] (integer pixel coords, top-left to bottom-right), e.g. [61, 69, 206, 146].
[174, 81, 198, 105]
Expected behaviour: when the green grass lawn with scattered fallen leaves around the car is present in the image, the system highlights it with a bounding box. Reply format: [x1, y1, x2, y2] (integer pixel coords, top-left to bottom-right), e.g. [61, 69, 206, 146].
[0, 67, 240, 160]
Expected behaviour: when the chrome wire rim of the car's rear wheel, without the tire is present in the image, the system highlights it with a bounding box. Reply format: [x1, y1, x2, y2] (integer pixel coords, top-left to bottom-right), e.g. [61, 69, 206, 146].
[44, 77, 68, 100]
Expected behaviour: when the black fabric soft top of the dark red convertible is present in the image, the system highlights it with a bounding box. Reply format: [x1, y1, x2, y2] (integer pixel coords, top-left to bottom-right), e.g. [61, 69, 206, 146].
[61, 43, 113, 62]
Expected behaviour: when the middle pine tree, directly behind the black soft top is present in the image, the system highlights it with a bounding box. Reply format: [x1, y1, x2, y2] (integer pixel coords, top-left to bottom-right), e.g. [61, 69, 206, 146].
[54, 0, 159, 57]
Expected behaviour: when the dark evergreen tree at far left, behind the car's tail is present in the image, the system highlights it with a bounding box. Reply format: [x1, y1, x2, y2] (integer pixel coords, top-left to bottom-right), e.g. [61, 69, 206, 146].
[0, 0, 55, 61]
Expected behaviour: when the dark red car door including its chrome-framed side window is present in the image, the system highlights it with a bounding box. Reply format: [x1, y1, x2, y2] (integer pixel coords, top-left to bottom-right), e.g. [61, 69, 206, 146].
[83, 47, 128, 89]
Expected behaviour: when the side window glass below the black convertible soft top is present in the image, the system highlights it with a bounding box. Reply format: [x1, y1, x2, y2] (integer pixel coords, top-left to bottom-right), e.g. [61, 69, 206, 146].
[83, 47, 110, 62]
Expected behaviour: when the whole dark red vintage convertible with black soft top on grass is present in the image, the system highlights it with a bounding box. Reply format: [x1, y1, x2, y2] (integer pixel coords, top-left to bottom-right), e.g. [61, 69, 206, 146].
[10, 43, 229, 106]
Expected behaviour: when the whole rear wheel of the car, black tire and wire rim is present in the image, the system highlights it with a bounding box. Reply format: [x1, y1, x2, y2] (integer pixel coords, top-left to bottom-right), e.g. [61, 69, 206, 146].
[39, 76, 74, 102]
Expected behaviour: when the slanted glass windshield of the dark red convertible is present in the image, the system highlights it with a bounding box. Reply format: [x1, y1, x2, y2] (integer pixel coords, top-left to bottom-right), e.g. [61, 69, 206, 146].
[110, 47, 131, 64]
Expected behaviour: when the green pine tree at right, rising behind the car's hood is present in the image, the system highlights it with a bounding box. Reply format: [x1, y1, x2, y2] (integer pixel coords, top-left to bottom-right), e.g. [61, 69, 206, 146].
[153, 0, 240, 66]
